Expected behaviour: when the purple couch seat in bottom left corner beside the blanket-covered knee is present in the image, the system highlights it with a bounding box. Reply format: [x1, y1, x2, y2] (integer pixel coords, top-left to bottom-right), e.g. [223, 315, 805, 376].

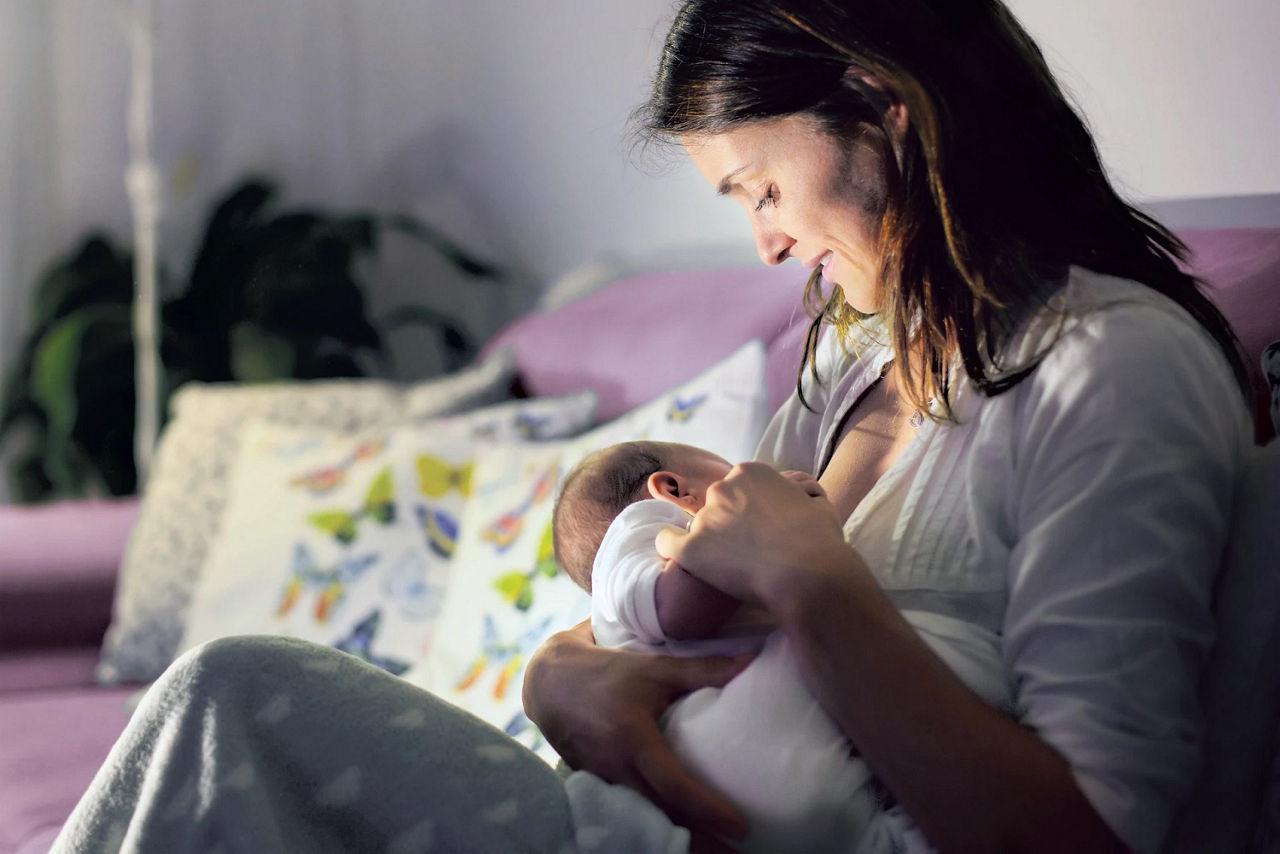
[0, 688, 136, 853]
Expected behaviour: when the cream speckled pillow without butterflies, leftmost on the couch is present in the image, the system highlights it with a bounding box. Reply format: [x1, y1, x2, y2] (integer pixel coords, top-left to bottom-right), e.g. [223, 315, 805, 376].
[96, 351, 515, 684]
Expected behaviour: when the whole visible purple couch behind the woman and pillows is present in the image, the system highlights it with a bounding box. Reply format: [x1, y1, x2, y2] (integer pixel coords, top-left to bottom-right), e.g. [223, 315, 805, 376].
[0, 229, 1280, 854]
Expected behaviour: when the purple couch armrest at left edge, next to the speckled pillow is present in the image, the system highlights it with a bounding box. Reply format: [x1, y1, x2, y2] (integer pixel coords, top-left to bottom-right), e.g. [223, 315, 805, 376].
[0, 499, 138, 650]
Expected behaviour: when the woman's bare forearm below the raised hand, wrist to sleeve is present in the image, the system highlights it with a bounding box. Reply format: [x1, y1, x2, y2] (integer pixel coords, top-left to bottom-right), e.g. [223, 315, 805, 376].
[777, 547, 1126, 851]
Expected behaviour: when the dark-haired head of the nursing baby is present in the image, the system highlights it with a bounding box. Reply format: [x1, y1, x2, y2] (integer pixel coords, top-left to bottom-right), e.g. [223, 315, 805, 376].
[552, 442, 733, 590]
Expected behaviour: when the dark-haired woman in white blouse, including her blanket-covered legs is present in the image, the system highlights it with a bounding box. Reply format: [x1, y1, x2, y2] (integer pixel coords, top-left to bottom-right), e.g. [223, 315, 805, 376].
[55, 0, 1248, 851]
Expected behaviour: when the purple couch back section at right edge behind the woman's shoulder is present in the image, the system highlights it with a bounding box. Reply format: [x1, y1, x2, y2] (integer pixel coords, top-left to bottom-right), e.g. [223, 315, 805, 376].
[1178, 228, 1280, 442]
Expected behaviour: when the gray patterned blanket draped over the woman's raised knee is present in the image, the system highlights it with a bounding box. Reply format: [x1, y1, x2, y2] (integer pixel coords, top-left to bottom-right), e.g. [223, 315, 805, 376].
[52, 638, 687, 854]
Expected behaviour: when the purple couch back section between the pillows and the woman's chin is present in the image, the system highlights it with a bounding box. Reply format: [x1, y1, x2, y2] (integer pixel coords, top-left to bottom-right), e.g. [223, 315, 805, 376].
[485, 264, 808, 421]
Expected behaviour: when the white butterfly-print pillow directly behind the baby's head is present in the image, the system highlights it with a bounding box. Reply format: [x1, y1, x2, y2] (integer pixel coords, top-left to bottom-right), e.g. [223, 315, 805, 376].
[406, 341, 769, 762]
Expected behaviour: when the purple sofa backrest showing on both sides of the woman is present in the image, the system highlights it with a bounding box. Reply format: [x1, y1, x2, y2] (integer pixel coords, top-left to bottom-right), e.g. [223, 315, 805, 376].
[485, 229, 1280, 438]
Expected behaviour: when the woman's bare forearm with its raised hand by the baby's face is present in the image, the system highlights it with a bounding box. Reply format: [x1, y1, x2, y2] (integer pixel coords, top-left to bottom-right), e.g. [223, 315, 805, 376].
[658, 463, 1125, 851]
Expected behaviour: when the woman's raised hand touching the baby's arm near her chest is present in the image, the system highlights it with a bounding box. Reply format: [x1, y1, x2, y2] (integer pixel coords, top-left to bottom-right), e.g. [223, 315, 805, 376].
[658, 462, 859, 611]
